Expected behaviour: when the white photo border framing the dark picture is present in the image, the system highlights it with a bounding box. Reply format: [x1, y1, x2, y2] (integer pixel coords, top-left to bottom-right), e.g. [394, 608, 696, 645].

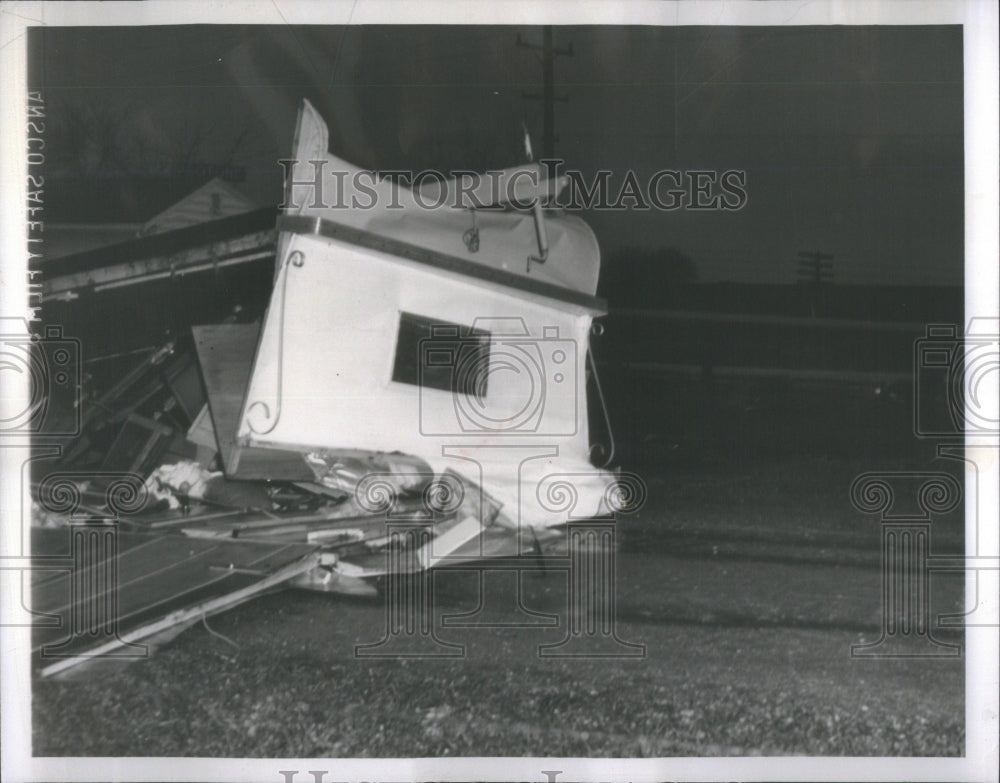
[0, 0, 1000, 783]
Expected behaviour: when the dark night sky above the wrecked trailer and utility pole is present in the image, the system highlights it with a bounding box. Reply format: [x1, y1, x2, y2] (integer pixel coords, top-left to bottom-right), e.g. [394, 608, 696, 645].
[29, 26, 964, 285]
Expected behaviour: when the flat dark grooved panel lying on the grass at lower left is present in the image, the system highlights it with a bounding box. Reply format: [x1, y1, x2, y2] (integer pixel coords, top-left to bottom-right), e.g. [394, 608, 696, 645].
[32, 525, 318, 676]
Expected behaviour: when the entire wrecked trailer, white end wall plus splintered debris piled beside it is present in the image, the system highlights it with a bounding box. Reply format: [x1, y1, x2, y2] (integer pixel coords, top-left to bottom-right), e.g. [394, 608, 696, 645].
[35, 102, 637, 674]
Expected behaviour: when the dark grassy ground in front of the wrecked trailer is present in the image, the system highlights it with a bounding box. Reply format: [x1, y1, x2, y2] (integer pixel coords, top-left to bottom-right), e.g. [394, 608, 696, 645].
[33, 440, 964, 757]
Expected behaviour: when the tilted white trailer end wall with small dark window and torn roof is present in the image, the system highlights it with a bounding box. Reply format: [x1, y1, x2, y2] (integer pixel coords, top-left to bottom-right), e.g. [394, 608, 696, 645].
[210, 103, 613, 553]
